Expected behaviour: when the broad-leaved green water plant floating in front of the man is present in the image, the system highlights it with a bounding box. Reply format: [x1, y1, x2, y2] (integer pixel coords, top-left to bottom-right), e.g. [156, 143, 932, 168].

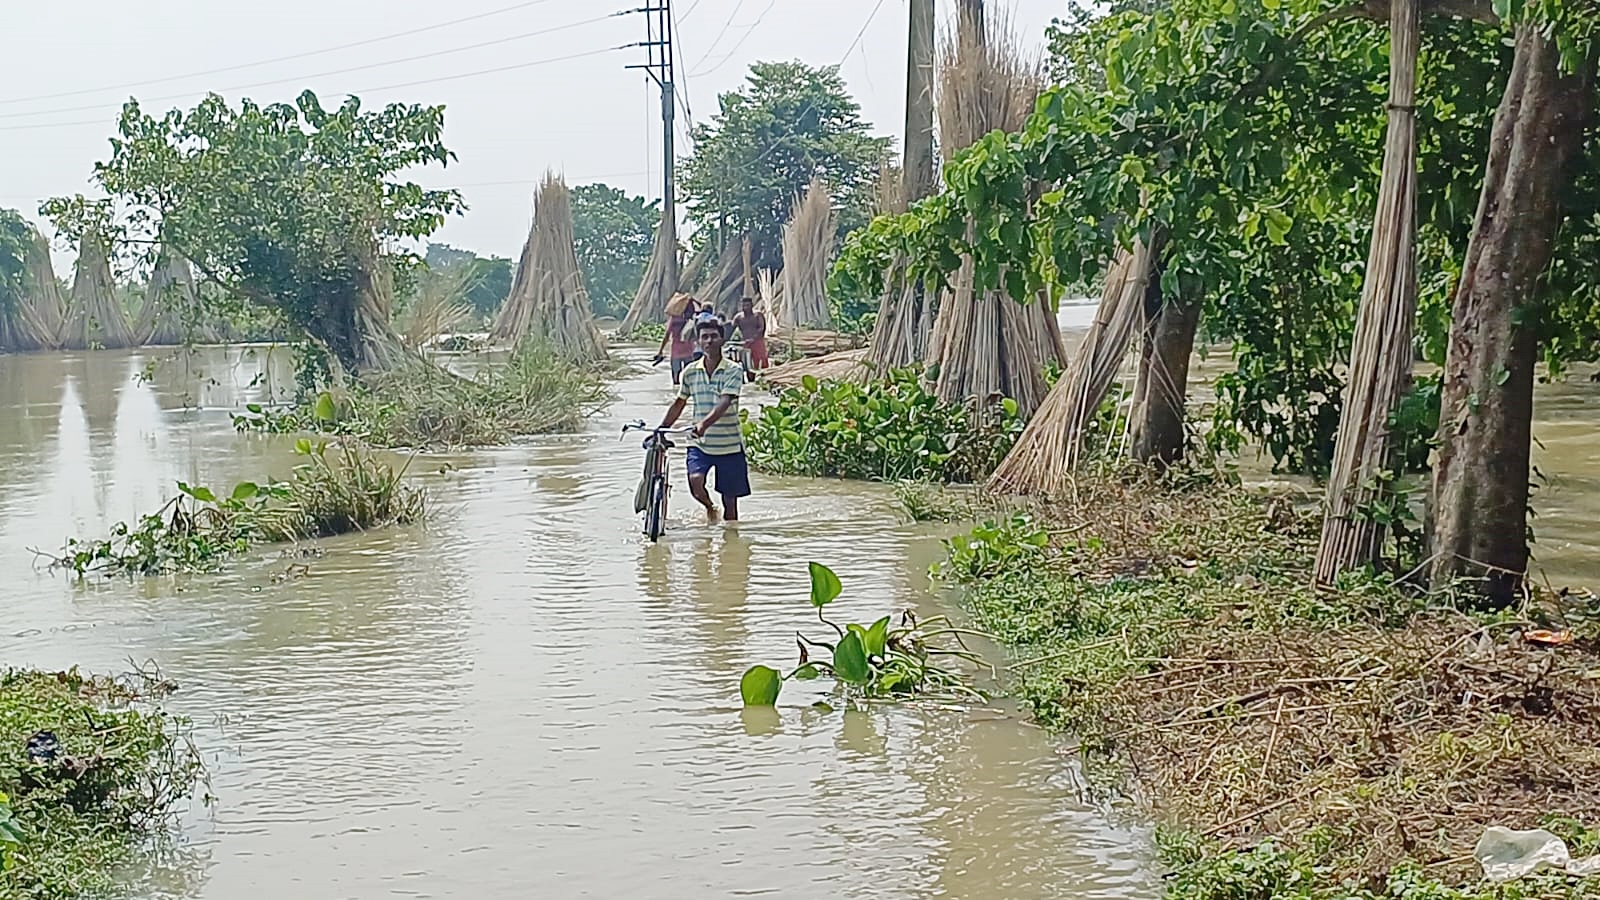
[739, 562, 984, 706]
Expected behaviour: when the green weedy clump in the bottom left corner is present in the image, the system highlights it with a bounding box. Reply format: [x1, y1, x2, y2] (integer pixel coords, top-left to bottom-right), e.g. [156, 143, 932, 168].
[0, 669, 203, 900]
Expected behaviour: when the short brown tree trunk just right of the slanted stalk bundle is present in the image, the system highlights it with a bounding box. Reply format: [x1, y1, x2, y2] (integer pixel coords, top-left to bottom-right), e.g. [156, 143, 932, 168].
[1133, 291, 1200, 469]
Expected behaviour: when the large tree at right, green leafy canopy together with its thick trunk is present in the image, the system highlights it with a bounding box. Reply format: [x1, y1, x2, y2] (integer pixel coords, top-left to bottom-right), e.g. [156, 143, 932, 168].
[840, 0, 1600, 595]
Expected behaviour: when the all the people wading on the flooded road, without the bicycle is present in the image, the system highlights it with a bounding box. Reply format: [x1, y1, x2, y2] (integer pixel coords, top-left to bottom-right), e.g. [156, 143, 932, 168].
[656, 293, 768, 522]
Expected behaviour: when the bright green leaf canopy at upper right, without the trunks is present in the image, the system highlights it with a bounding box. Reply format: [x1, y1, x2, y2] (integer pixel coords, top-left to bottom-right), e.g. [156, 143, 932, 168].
[832, 0, 1600, 474]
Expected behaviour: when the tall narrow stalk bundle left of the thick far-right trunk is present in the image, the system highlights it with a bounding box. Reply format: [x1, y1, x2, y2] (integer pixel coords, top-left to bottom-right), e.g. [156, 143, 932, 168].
[1315, 0, 1421, 585]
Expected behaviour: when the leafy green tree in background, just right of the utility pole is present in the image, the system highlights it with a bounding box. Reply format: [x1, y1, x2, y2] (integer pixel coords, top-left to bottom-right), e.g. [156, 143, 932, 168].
[678, 62, 890, 269]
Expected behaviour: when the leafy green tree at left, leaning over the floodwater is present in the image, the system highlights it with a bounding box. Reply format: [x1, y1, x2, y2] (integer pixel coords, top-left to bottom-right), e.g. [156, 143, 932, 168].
[43, 91, 464, 376]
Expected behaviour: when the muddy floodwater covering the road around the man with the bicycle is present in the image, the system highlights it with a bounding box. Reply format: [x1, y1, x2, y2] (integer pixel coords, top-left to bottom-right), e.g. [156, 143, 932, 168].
[0, 349, 1158, 900]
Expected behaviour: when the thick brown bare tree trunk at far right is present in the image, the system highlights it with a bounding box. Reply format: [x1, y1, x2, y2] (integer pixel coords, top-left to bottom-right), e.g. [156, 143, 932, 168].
[1430, 26, 1594, 607]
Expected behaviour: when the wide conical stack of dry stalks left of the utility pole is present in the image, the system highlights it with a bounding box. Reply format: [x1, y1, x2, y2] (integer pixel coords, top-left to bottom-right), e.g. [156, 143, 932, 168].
[490, 175, 606, 360]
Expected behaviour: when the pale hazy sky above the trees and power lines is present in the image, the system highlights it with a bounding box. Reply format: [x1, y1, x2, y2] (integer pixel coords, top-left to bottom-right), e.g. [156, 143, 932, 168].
[12, 0, 1064, 256]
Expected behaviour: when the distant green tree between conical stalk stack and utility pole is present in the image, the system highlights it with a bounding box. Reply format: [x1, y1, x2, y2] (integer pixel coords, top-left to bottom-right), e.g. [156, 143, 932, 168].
[573, 184, 661, 319]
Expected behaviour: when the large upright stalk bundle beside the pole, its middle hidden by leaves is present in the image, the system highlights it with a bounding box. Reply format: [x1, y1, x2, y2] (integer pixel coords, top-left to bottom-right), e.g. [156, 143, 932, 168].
[921, 6, 1061, 415]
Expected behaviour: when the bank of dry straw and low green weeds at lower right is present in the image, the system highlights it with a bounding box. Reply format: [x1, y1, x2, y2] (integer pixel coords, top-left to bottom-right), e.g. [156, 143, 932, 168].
[970, 469, 1600, 884]
